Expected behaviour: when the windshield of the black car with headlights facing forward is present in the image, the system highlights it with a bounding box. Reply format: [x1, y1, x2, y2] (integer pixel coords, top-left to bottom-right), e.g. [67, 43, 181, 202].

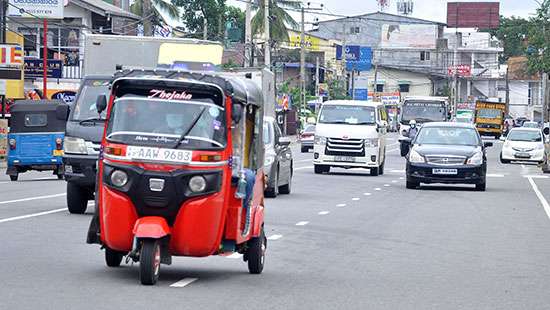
[415, 127, 480, 145]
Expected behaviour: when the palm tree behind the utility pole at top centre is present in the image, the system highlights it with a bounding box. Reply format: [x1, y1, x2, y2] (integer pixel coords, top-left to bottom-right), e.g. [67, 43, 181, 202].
[252, 0, 302, 42]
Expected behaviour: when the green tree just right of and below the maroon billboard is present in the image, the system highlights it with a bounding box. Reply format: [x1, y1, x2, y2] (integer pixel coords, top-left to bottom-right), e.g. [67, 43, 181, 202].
[481, 16, 529, 63]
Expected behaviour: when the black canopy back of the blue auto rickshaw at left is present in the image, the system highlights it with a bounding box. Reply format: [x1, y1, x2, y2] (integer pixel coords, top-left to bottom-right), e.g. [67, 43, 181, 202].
[9, 100, 67, 133]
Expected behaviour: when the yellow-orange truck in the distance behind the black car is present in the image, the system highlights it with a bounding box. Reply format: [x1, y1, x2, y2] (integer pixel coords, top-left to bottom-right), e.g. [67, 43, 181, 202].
[475, 101, 506, 139]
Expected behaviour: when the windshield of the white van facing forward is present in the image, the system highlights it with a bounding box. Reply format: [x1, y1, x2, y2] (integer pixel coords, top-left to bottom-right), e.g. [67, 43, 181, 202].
[319, 105, 376, 125]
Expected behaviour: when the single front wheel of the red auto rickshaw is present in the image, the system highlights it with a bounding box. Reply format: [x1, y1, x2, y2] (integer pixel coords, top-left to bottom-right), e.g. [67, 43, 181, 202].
[139, 239, 161, 285]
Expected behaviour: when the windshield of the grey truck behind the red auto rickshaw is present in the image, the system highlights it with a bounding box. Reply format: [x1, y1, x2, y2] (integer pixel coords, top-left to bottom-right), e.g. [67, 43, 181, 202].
[71, 80, 109, 121]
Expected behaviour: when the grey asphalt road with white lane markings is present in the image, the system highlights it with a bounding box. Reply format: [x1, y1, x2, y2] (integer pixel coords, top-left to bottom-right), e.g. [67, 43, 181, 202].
[0, 137, 550, 309]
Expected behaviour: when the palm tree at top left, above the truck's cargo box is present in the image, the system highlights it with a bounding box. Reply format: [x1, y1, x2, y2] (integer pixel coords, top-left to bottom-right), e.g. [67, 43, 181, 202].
[130, 0, 180, 36]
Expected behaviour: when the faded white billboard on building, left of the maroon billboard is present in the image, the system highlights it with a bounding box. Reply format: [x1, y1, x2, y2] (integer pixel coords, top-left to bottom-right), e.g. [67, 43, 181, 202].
[380, 24, 438, 49]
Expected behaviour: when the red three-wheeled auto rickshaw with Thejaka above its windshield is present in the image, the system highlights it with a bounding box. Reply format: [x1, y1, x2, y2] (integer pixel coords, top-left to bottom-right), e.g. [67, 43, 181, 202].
[87, 70, 267, 285]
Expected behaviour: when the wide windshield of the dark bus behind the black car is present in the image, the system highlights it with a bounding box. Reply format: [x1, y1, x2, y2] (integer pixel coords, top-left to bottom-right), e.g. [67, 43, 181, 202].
[401, 101, 447, 123]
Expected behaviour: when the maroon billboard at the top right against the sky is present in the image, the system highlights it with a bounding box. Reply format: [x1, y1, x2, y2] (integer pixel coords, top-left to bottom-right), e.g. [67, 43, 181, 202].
[447, 2, 500, 29]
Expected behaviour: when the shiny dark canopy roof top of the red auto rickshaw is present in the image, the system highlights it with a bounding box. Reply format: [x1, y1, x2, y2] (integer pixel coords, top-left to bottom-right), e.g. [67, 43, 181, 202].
[113, 69, 263, 107]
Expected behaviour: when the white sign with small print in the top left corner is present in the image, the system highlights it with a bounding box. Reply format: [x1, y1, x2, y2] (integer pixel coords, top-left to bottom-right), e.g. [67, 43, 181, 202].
[8, 0, 64, 19]
